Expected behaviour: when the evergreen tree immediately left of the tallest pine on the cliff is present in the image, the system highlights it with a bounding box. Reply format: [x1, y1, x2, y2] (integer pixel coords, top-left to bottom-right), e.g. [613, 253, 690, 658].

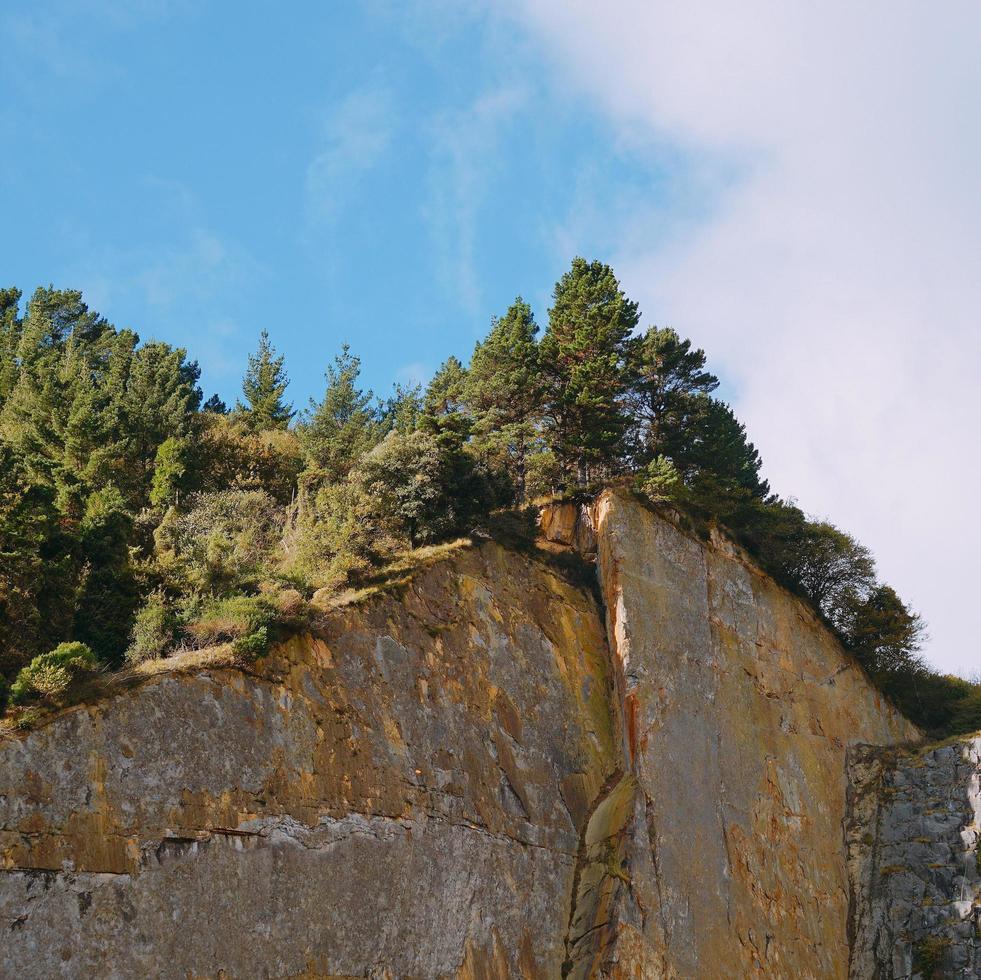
[464, 296, 542, 498]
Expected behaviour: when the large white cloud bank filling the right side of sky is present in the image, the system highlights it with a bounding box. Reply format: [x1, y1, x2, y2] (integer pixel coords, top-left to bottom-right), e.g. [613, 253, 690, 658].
[516, 0, 981, 672]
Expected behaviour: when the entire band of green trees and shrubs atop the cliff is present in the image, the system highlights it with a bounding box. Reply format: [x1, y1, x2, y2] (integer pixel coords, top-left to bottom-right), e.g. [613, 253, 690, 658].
[0, 258, 981, 732]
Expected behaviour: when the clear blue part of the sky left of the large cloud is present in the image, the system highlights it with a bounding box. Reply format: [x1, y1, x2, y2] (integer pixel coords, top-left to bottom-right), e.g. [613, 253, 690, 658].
[0, 0, 728, 404]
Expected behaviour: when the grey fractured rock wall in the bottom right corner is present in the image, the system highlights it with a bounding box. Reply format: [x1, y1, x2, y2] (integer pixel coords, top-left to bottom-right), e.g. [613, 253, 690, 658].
[848, 736, 981, 980]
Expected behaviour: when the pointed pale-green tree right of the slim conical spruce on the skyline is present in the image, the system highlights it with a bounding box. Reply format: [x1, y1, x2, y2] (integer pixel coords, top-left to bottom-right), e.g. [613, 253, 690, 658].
[300, 344, 381, 481]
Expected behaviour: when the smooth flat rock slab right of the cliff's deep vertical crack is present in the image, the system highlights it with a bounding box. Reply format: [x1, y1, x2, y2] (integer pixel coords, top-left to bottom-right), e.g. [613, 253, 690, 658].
[573, 494, 917, 978]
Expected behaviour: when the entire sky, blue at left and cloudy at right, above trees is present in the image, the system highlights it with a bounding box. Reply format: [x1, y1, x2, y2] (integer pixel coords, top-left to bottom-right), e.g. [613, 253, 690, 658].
[0, 0, 981, 674]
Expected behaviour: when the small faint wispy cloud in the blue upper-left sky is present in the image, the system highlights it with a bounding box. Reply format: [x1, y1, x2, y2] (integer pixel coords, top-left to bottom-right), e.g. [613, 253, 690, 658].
[306, 88, 395, 220]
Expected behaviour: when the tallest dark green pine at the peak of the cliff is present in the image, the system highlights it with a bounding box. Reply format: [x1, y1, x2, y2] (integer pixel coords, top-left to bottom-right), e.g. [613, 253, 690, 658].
[539, 258, 639, 486]
